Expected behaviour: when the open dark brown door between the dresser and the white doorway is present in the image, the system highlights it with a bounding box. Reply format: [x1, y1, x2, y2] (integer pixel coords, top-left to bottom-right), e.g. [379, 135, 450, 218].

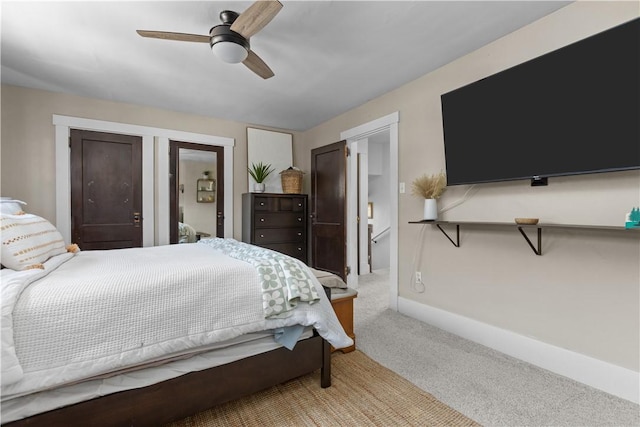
[311, 141, 347, 280]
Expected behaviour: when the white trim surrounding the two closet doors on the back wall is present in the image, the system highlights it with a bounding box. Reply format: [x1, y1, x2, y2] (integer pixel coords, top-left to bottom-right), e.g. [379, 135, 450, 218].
[53, 114, 235, 246]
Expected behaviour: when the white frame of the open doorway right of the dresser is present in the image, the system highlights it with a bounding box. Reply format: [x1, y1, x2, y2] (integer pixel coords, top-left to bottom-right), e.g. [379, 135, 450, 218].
[340, 111, 400, 311]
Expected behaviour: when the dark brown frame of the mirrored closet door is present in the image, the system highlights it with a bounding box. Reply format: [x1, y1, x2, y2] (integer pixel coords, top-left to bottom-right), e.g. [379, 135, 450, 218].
[169, 141, 224, 244]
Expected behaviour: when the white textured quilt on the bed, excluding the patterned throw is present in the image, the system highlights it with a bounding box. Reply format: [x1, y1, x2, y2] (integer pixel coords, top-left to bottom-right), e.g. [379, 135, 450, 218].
[2, 244, 352, 401]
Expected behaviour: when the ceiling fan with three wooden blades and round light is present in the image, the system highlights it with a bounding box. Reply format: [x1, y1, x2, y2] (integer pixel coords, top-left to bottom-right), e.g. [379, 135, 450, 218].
[136, 0, 282, 79]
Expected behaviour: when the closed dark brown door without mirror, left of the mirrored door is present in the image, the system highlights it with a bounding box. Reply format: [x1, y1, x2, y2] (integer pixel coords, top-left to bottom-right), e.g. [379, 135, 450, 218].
[71, 129, 142, 250]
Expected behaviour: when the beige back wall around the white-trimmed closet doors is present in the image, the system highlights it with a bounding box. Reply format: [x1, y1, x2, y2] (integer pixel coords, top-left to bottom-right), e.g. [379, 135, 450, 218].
[0, 85, 303, 239]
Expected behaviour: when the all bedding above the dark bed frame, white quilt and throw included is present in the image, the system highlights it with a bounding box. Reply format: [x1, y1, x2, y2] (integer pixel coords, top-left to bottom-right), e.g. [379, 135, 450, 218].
[1, 215, 352, 423]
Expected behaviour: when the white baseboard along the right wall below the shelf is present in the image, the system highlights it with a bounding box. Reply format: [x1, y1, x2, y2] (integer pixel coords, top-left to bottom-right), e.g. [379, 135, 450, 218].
[398, 297, 640, 403]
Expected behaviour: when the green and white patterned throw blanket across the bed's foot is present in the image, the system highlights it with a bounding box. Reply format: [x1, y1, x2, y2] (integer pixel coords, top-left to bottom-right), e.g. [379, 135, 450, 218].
[199, 238, 320, 318]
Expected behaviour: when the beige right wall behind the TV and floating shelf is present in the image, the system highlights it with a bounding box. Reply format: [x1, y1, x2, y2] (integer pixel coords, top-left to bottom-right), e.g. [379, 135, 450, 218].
[303, 2, 640, 371]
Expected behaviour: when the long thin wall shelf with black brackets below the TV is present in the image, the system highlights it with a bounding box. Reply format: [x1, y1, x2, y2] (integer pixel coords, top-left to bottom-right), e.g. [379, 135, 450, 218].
[409, 220, 640, 255]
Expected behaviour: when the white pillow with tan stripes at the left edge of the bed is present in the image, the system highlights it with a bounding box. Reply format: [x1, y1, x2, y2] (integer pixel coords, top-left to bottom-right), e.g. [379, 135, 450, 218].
[0, 213, 67, 270]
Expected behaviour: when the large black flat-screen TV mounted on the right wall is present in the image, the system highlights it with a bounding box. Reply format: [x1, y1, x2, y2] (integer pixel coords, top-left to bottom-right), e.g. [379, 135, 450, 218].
[441, 18, 640, 185]
